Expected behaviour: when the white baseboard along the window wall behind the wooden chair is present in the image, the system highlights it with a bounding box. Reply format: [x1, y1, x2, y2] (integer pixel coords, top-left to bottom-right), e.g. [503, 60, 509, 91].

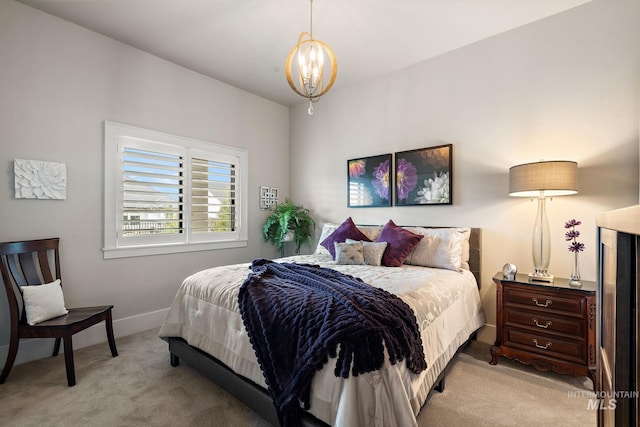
[0, 308, 169, 366]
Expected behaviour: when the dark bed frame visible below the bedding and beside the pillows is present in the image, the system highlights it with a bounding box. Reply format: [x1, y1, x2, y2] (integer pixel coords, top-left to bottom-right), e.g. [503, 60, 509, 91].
[166, 227, 481, 427]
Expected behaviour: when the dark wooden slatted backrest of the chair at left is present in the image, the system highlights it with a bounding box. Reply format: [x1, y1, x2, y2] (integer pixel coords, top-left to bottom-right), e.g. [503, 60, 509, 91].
[0, 237, 61, 330]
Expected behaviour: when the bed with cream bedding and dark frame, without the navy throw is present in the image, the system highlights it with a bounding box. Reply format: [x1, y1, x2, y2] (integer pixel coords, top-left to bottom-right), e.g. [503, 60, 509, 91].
[159, 223, 484, 427]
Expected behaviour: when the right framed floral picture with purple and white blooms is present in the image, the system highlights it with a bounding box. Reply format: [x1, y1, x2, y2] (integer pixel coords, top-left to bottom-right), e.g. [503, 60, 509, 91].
[394, 144, 453, 206]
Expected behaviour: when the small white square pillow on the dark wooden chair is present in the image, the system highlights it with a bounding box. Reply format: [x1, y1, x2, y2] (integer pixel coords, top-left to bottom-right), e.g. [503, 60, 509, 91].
[21, 279, 68, 325]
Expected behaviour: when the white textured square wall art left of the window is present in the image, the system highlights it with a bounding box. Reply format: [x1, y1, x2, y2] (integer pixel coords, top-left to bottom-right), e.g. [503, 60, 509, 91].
[13, 159, 67, 200]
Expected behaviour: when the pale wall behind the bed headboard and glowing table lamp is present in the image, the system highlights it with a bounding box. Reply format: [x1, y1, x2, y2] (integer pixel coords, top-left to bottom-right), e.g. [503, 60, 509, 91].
[291, 0, 640, 341]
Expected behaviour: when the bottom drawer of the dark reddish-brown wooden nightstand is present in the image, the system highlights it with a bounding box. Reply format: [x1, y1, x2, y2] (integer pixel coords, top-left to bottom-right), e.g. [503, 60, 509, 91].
[505, 327, 587, 363]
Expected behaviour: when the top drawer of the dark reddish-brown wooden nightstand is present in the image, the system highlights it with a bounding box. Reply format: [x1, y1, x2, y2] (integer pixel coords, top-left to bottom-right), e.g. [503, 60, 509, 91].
[504, 287, 585, 316]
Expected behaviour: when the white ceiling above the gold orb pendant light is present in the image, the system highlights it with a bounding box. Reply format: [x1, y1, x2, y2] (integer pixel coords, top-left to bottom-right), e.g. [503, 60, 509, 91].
[16, 0, 590, 105]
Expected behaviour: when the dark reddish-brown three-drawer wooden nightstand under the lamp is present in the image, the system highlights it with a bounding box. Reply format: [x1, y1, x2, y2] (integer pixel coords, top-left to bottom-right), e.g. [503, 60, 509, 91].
[490, 273, 596, 384]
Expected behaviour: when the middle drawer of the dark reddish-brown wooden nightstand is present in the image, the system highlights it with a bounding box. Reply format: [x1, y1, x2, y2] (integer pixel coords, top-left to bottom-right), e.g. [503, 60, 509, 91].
[504, 308, 585, 340]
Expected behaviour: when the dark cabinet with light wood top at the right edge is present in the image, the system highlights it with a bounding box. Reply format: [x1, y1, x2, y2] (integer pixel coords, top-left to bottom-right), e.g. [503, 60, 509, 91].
[596, 206, 640, 426]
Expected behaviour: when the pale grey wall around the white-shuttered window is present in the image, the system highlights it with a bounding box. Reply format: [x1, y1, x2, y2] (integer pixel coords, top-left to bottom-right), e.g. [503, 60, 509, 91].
[0, 1, 289, 361]
